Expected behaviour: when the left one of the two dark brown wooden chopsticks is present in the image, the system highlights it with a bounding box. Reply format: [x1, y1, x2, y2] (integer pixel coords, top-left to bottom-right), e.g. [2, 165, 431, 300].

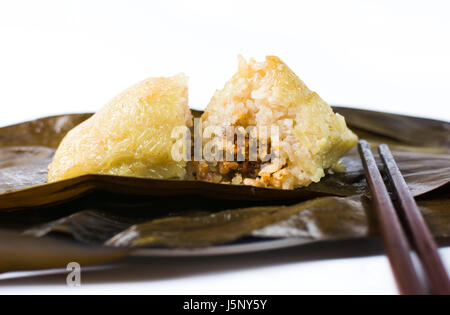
[358, 140, 427, 295]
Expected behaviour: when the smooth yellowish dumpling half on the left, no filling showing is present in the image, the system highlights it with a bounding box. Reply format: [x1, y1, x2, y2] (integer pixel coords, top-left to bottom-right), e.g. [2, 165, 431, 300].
[48, 74, 192, 182]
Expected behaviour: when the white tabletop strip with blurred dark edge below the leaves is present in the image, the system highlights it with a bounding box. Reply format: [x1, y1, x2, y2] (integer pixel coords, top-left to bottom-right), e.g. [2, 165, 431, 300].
[0, 240, 450, 295]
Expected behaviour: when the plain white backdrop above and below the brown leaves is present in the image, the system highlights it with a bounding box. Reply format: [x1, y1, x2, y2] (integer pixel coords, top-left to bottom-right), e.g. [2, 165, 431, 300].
[0, 0, 450, 294]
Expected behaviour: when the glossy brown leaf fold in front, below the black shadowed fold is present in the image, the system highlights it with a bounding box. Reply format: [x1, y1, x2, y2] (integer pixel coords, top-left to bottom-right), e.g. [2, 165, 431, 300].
[18, 195, 450, 248]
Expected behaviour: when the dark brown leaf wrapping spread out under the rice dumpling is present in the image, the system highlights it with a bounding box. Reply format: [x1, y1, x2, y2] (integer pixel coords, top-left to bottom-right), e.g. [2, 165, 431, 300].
[0, 107, 450, 272]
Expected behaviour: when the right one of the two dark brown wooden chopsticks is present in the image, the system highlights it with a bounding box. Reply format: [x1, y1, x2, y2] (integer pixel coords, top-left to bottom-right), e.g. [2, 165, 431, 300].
[378, 144, 450, 295]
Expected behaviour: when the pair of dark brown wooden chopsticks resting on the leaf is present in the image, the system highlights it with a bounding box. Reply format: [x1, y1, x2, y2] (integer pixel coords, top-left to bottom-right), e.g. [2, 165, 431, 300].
[358, 140, 450, 295]
